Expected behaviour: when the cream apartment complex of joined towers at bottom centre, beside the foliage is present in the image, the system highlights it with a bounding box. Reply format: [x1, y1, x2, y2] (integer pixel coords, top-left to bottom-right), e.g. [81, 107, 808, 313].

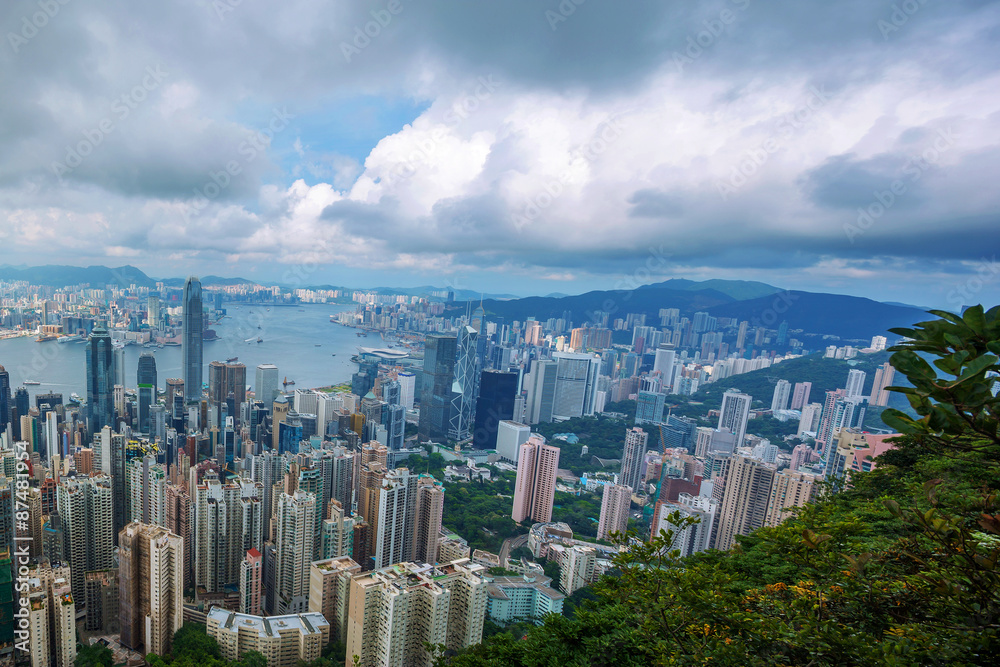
[347, 561, 488, 667]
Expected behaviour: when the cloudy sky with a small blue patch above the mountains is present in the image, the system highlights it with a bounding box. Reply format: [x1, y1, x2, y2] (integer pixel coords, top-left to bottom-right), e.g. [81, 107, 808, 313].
[0, 0, 1000, 309]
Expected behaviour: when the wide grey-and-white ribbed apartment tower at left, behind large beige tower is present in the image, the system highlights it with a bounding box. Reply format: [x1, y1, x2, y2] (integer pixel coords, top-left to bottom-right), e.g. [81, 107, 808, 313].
[56, 476, 114, 605]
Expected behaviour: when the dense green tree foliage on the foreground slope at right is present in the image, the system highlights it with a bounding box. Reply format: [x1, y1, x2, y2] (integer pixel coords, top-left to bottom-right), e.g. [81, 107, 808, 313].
[440, 308, 1000, 667]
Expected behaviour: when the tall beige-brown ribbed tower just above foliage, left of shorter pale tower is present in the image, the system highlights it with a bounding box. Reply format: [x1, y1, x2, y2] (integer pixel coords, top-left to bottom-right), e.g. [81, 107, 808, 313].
[714, 456, 775, 551]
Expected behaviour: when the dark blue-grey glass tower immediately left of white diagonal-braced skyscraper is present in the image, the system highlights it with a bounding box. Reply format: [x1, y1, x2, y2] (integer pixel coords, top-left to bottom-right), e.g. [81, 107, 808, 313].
[417, 334, 458, 442]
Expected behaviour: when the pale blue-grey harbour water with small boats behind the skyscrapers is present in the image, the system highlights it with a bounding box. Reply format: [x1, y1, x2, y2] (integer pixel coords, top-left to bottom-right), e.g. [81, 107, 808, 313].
[0, 304, 368, 405]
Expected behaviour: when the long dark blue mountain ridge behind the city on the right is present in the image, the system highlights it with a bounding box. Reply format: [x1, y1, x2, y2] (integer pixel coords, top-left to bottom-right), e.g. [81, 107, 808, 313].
[452, 279, 926, 341]
